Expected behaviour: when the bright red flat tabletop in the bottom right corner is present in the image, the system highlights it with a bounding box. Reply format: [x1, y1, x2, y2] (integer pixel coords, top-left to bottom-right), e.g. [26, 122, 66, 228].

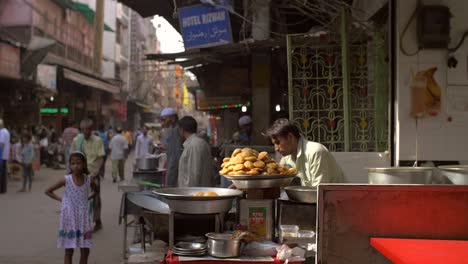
[370, 238, 468, 264]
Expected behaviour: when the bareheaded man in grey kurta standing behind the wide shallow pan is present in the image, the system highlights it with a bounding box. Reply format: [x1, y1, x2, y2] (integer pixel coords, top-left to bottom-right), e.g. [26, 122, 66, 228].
[178, 116, 214, 187]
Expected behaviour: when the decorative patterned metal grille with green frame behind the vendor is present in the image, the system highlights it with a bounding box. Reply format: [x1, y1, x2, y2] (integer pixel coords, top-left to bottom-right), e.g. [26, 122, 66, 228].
[288, 27, 385, 152]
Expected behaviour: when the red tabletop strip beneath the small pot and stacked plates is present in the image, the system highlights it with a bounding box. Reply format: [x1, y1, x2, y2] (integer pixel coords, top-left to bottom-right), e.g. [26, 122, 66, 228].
[166, 250, 302, 264]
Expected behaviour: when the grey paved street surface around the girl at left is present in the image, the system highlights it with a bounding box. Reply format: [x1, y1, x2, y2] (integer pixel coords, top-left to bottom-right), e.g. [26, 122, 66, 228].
[0, 159, 135, 264]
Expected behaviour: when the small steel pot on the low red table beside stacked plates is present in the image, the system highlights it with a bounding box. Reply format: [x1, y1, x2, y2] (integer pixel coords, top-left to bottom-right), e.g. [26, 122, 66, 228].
[206, 233, 241, 258]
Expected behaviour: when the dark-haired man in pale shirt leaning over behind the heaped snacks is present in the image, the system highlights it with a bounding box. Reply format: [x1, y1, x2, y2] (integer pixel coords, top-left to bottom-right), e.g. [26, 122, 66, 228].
[265, 119, 345, 186]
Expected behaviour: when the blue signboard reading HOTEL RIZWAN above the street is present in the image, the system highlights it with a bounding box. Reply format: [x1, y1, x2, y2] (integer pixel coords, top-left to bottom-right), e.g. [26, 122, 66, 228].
[179, 5, 232, 49]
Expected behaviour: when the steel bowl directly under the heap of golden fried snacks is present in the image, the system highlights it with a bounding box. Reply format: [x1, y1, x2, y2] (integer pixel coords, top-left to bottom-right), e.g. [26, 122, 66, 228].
[222, 174, 296, 189]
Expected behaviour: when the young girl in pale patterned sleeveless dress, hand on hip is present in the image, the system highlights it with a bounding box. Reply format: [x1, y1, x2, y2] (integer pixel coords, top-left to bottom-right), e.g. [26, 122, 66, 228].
[46, 151, 96, 264]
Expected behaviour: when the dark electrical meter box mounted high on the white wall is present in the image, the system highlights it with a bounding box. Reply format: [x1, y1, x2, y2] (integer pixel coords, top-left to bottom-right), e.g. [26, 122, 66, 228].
[418, 5, 451, 49]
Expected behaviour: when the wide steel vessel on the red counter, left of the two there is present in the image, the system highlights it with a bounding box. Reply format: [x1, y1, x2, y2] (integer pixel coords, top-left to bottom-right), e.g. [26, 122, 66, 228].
[367, 167, 434, 184]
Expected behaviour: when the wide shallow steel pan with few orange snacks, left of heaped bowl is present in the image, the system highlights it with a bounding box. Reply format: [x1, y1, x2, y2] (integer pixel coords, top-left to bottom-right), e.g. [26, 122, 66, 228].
[153, 187, 242, 214]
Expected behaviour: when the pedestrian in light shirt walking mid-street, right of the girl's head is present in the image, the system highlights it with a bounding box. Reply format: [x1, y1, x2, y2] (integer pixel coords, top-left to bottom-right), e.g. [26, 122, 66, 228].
[109, 127, 128, 182]
